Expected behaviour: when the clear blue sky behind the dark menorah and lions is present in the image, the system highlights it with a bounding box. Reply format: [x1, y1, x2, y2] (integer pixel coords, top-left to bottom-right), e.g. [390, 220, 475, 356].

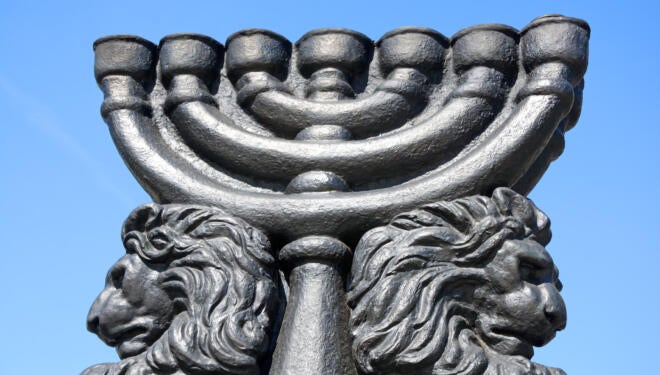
[0, 0, 660, 375]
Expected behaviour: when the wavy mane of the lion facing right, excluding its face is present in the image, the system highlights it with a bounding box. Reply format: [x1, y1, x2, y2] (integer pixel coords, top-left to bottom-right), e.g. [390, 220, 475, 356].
[348, 188, 563, 375]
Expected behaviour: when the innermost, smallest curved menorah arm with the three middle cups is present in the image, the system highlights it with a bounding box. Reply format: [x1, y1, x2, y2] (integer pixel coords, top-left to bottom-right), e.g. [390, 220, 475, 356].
[227, 27, 448, 139]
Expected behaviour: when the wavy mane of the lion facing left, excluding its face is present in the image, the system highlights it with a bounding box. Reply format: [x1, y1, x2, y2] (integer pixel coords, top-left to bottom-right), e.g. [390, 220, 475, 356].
[83, 204, 278, 375]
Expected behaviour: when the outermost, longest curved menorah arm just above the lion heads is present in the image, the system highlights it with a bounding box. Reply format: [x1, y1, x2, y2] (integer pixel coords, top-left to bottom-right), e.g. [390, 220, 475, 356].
[97, 15, 583, 243]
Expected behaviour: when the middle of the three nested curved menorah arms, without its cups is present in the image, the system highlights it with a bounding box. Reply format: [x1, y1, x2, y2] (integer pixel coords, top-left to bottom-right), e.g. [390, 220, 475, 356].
[170, 98, 497, 184]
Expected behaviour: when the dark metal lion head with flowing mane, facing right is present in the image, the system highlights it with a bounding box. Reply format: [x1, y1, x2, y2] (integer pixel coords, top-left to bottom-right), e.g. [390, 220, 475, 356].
[348, 188, 566, 375]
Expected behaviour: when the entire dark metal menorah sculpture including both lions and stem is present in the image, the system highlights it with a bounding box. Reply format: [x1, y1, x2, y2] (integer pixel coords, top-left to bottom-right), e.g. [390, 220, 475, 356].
[85, 15, 589, 374]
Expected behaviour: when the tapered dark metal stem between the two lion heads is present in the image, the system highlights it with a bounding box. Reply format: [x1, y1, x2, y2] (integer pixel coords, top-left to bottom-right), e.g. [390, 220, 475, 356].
[270, 236, 356, 375]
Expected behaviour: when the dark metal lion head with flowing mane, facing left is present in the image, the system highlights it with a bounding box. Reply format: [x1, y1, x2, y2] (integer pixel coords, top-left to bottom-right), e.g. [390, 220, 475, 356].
[83, 204, 278, 375]
